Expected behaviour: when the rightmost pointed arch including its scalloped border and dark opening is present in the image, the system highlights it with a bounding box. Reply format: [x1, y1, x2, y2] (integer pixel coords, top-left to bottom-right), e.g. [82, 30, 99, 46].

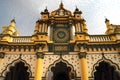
[91, 56, 120, 80]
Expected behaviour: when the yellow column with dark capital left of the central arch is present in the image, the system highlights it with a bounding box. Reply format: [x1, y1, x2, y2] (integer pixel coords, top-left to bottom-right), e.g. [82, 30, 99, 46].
[35, 52, 44, 80]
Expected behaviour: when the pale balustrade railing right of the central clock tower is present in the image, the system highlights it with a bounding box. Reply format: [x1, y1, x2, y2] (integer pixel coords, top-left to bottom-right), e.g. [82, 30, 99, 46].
[90, 35, 112, 41]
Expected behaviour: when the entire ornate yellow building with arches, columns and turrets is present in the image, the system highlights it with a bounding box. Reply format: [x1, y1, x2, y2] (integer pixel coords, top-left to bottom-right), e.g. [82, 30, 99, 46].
[0, 3, 120, 80]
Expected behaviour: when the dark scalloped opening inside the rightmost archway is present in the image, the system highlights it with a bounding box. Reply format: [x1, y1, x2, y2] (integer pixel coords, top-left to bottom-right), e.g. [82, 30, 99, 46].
[94, 61, 120, 80]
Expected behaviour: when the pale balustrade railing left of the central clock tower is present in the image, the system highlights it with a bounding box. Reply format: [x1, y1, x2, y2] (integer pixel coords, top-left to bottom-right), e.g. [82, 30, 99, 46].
[12, 36, 31, 42]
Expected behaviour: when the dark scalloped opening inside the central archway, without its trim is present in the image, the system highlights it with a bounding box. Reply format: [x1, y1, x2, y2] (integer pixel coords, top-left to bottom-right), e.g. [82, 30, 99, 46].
[51, 61, 71, 80]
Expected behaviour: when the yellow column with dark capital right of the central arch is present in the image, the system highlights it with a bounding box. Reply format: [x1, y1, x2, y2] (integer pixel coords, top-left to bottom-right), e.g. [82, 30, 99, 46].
[79, 52, 88, 80]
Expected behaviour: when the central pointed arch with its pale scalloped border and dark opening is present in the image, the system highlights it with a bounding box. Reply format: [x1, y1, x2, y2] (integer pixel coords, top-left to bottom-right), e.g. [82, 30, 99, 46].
[47, 57, 76, 80]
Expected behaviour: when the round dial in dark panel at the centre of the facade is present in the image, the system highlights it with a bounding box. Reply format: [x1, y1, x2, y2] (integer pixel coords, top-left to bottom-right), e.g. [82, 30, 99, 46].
[54, 28, 69, 43]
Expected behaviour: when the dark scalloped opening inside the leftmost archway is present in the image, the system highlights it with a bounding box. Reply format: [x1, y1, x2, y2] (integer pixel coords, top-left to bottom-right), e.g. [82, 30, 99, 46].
[4, 61, 29, 80]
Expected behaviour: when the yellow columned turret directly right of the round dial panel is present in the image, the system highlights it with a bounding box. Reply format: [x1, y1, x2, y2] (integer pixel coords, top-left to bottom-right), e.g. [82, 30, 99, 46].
[74, 7, 88, 40]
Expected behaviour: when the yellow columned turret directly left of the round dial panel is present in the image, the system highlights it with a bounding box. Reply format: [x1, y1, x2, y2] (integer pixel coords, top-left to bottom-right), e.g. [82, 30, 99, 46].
[32, 7, 49, 40]
